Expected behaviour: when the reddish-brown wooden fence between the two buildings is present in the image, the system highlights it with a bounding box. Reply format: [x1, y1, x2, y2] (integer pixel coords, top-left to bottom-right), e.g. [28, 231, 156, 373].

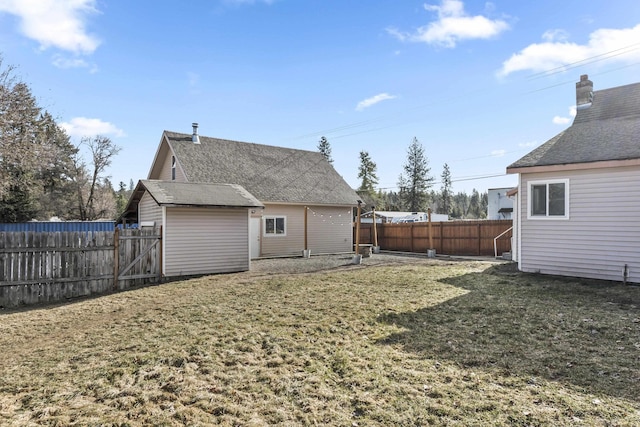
[360, 220, 512, 256]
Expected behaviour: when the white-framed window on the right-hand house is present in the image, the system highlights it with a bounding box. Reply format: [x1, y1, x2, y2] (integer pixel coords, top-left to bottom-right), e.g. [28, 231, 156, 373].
[528, 179, 569, 219]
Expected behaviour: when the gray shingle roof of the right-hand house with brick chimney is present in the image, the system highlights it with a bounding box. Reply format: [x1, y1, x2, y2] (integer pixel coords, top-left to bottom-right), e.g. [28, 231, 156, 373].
[507, 83, 640, 170]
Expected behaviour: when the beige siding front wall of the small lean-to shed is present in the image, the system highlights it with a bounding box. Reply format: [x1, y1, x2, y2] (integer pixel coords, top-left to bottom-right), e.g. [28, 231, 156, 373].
[164, 208, 249, 276]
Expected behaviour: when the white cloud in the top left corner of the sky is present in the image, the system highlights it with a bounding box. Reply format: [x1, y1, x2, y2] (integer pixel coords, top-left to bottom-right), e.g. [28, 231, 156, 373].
[0, 0, 100, 54]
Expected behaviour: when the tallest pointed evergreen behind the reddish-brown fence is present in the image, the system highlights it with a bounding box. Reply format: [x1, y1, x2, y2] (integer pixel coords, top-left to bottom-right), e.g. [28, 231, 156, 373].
[398, 137, 433, 212]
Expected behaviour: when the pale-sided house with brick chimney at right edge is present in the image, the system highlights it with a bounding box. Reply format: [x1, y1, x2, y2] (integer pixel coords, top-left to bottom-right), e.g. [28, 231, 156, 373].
[507, 75, 640, 282]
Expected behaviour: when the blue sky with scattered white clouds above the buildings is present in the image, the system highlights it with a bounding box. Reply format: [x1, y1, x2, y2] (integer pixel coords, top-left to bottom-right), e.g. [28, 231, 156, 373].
[0, 0, 640, 193]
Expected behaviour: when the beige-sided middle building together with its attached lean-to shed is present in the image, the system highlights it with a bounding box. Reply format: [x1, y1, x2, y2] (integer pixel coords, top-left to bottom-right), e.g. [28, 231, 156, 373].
[121, 123, 359, 274]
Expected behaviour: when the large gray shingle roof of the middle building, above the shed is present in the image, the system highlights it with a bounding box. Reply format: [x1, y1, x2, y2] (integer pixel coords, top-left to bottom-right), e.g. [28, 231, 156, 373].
[164, 131, 359, 205]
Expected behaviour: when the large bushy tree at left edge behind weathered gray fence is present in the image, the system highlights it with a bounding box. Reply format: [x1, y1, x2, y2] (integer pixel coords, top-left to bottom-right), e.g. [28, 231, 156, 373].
[0, 56, 74, 222]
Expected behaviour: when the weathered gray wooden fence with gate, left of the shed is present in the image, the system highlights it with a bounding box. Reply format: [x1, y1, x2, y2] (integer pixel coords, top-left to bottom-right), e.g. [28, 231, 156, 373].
[0, 229, 162, 307]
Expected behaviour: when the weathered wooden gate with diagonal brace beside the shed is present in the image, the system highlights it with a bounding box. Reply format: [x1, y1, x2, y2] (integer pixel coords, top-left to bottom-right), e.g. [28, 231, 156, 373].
[113, 227, 162, 289]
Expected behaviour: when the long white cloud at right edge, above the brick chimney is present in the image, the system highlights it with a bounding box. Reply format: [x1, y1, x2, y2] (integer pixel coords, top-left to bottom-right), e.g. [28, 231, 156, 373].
[498, 24, 640, 77]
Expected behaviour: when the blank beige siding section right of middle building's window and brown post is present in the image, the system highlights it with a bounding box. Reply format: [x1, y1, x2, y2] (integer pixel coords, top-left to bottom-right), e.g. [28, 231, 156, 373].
[307, 206, 353, 254]
